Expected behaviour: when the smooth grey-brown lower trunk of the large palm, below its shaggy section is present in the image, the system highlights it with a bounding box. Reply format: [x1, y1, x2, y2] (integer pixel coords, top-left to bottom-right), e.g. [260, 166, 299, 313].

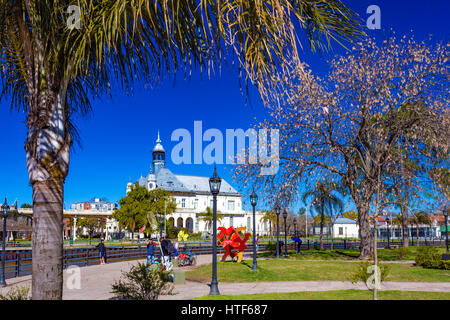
[32, 180, 64, 300]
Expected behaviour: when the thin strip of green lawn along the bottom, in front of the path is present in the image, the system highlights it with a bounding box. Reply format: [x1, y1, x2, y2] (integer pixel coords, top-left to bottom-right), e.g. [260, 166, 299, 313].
[192, 290, 450, 300]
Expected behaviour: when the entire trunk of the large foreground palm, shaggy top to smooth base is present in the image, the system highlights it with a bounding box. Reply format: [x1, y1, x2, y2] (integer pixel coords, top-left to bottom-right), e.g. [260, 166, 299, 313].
[25, 86, 72, 300]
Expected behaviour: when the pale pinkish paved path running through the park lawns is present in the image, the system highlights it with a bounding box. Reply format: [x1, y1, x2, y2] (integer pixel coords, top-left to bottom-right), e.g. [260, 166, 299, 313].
[0, 255, 450, 300]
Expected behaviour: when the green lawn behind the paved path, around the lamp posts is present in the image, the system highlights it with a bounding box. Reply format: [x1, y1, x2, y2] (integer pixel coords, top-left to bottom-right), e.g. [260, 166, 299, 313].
[186, 259, 450, 282]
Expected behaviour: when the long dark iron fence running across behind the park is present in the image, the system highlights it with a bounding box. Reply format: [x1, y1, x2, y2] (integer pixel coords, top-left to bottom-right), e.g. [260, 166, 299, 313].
[0, 238, 445, 279]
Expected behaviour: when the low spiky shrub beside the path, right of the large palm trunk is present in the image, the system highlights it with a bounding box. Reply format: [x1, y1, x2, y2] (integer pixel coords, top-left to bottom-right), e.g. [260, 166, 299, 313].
[112, 262, 173, 300]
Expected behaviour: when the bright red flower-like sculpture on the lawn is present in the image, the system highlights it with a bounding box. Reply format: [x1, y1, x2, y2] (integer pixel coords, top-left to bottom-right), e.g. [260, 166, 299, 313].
[217, 226, 250, 262]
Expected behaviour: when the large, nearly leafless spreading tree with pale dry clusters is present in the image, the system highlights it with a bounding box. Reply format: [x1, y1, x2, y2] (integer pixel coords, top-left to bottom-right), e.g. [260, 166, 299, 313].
[235, 38, 450, 259]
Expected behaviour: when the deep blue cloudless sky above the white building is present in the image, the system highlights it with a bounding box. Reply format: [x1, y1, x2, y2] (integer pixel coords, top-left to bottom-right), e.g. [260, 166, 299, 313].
[0, 0, 450, 212]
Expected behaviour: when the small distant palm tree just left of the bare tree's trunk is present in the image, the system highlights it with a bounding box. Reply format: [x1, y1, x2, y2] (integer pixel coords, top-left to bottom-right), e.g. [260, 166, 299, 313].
[302, 181, 344, 250]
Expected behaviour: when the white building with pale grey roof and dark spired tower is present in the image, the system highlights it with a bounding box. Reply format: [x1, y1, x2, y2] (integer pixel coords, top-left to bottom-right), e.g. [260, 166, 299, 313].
[127, 133, 269, 238]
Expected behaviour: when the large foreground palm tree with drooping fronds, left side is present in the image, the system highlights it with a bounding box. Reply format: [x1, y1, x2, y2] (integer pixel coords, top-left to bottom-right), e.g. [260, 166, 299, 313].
[0, 0, 363, 299]
